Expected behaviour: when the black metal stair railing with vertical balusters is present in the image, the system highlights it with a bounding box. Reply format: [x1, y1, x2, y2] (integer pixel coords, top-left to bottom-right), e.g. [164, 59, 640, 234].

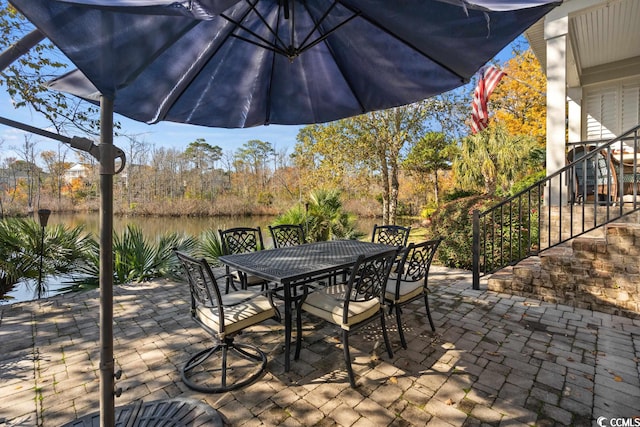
[472, 124, 640, 289]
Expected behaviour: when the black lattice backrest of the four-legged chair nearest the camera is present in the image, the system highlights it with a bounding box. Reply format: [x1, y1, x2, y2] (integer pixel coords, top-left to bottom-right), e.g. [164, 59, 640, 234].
[344, 249, 398, 312]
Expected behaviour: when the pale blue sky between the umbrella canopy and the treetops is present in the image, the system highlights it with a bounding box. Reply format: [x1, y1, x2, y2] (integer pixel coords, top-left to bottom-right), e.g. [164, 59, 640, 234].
[0, 37, 526, 160]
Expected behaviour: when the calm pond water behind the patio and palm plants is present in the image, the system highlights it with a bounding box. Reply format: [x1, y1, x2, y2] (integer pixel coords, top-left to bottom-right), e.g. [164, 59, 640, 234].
[0, 213, 376, 305]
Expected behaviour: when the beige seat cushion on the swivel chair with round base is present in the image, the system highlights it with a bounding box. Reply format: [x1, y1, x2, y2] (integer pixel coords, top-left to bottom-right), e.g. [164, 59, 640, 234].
[196, 291, 276, 339]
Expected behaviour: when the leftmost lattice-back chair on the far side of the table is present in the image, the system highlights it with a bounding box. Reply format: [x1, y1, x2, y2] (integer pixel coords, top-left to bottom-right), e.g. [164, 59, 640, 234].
[218, 227, 268, 290]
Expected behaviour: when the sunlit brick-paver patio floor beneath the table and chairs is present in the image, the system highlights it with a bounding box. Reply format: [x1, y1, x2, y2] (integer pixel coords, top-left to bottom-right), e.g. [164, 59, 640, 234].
[0, 266, 640, 426]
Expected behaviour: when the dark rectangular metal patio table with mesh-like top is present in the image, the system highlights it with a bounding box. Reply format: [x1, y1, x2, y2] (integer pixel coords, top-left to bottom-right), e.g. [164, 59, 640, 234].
[219, 240, 396, 372]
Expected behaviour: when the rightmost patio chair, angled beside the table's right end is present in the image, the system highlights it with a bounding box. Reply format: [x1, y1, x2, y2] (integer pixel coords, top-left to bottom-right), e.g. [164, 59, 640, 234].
[385, 239, 442, 349]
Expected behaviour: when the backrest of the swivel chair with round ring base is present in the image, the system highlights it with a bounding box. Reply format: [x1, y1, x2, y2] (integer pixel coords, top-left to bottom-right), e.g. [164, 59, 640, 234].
[174, 250, 224, 334]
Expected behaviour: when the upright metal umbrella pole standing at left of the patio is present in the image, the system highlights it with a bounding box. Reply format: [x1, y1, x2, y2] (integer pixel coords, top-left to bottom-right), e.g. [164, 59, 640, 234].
[99, 95, 115, 426]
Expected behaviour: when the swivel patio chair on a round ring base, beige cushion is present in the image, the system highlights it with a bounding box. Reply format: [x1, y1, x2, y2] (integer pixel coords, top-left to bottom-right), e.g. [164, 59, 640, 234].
[174, 251, 280, 393]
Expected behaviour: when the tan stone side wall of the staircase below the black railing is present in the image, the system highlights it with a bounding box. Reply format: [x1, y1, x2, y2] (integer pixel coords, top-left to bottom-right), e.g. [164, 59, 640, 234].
[487, 222, 640, 318]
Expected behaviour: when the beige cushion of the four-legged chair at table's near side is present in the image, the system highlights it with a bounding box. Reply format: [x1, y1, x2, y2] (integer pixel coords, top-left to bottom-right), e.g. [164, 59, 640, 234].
[301, 284, 380, 330]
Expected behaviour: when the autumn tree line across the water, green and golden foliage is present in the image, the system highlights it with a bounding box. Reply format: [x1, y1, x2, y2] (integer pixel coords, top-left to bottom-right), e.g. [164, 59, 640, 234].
[0, 0, 546, 266]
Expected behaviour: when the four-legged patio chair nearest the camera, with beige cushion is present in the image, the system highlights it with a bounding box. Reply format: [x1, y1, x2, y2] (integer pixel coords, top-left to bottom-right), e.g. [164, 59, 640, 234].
[295, 249, 398, 388]
